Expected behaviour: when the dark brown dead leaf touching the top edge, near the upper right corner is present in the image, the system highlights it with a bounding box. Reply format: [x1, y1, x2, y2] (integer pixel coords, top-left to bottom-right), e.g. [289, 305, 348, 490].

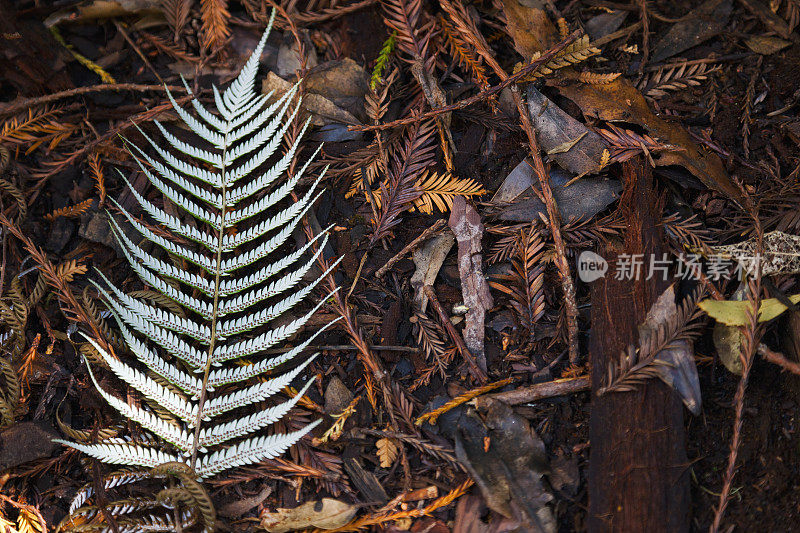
[652, 0, 733, 62]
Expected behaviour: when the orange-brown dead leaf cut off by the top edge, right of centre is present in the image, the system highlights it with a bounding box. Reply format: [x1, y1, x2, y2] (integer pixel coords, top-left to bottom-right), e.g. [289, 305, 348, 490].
[503, 0, 558, 60]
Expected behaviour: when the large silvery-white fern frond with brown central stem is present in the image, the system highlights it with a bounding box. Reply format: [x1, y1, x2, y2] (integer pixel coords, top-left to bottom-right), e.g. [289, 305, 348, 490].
[55, 18, 332, 479]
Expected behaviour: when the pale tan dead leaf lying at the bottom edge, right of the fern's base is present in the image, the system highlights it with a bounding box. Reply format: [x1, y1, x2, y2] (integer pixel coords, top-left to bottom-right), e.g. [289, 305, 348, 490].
[261, 498, 358, 533]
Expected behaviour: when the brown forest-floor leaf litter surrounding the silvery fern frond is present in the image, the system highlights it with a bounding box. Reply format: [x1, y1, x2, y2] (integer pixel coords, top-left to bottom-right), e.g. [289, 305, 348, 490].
[0, 0, 800, 533]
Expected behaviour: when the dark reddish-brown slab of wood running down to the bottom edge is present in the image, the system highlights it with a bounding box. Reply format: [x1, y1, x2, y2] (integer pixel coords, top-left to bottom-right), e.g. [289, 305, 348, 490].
[587, 158, 689, 532]
